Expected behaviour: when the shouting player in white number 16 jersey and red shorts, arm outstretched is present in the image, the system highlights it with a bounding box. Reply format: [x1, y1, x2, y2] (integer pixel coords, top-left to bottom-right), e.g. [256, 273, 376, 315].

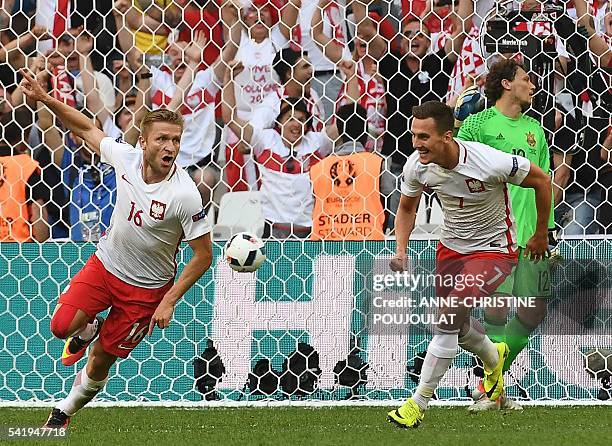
[20, 70, 212, 428]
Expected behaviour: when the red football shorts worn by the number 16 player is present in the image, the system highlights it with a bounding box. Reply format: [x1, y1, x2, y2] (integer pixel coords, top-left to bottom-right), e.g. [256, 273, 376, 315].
[59, 254, 173, 358]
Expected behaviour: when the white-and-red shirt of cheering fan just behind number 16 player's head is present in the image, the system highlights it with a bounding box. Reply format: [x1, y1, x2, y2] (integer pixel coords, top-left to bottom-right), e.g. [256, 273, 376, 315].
[151, 67, 221, 167]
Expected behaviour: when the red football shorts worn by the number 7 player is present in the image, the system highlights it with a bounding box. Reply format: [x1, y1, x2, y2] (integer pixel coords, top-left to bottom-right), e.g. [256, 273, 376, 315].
[436, 243, 518, 297]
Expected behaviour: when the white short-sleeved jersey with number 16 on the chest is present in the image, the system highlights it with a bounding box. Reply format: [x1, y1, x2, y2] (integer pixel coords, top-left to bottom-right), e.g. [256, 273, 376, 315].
[96, 138, 211, 288]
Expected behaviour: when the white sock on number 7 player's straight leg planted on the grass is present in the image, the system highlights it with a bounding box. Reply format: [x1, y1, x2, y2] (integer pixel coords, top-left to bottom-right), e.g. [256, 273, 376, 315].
[412, 333, 458, 410]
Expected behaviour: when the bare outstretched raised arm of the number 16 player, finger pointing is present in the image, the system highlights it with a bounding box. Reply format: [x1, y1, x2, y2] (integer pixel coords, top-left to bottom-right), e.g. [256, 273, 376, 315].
[19, 69, 105, 155]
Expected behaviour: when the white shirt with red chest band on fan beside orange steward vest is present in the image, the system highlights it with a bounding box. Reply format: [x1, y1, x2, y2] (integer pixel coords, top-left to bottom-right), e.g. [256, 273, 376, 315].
[252, 129, 333, 227]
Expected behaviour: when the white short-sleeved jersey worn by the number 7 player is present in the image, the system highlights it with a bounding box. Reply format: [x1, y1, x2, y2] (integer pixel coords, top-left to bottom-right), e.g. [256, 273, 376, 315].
[401, 140, 530, 254]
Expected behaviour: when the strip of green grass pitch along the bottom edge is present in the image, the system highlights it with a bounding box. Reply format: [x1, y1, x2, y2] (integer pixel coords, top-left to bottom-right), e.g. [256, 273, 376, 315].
[0, 406, 612, 446]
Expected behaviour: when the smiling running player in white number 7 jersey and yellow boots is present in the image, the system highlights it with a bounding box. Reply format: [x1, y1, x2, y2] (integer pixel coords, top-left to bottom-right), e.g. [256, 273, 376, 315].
[388, 101, 552, 427]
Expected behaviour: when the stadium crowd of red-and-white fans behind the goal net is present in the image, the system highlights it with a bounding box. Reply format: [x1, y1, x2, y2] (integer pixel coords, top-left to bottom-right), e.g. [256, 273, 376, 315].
[0, 0, 612, 242]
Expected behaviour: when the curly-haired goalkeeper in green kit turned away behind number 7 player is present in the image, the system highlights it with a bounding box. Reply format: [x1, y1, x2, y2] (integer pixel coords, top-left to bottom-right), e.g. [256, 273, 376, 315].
[455, 59, 554, 410]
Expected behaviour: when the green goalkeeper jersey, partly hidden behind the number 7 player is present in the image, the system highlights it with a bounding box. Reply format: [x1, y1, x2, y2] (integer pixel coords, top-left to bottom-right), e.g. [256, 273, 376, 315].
[457, 107, 555, 248]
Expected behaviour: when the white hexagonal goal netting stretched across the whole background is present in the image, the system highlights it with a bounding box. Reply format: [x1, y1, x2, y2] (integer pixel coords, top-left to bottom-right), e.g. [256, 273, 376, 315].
[0, 0, 612, 401]
